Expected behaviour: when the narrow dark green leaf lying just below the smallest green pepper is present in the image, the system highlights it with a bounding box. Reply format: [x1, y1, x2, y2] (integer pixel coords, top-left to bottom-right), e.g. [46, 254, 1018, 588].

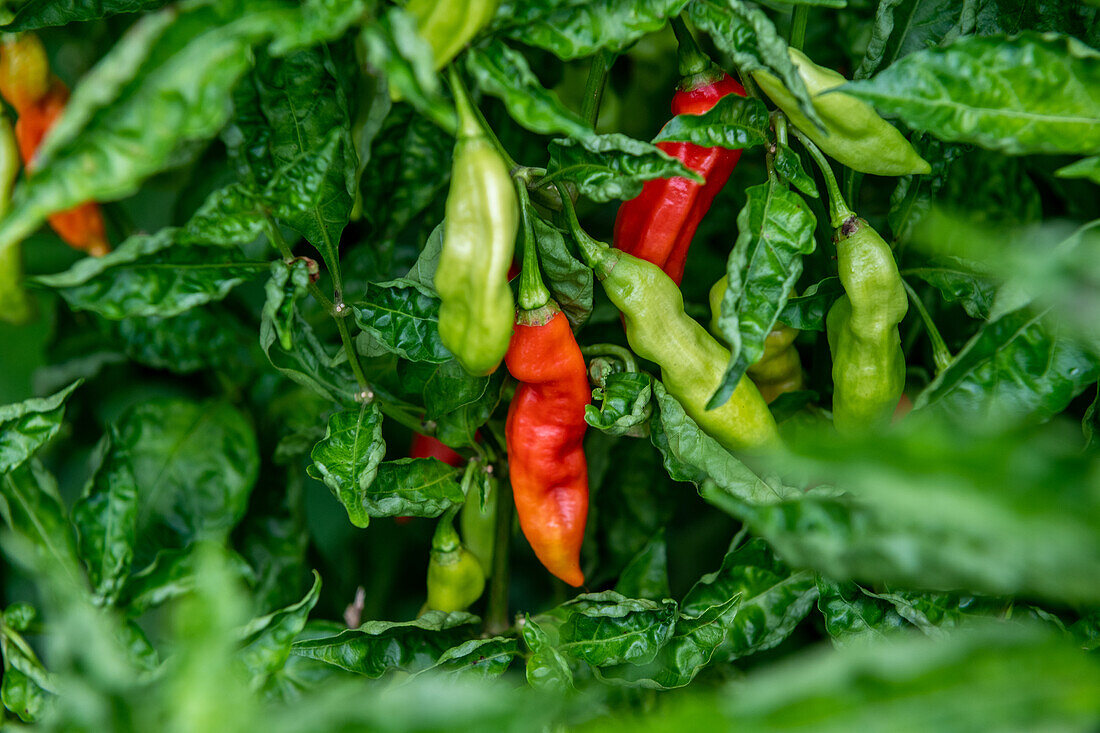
[292, 611, 477, 679]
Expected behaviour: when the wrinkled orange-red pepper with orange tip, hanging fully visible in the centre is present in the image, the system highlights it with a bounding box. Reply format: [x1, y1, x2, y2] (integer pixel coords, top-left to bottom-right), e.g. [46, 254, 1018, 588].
[504, 302, 592, 586]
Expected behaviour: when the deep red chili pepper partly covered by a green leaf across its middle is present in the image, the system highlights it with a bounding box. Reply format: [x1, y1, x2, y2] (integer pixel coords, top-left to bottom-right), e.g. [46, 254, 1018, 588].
[615, 23, 745, 285]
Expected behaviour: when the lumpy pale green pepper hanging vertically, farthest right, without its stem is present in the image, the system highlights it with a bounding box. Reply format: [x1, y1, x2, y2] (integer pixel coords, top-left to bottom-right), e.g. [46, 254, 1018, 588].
[825, 216, 909, 433]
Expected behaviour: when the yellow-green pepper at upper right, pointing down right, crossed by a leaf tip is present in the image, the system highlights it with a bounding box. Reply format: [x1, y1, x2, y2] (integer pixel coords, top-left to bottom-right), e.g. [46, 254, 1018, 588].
[752, 48, 932, 176]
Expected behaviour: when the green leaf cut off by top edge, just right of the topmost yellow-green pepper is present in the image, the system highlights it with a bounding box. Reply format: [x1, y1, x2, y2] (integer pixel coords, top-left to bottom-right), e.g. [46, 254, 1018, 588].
[494, 0, 688, 61]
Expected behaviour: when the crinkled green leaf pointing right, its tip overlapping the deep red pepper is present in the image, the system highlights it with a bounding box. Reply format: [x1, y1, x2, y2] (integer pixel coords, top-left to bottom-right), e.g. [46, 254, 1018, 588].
[548, 133, 703, 201]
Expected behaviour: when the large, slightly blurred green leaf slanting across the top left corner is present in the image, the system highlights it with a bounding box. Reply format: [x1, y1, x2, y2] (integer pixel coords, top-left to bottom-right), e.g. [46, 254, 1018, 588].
[0, 0, 363, 250]
